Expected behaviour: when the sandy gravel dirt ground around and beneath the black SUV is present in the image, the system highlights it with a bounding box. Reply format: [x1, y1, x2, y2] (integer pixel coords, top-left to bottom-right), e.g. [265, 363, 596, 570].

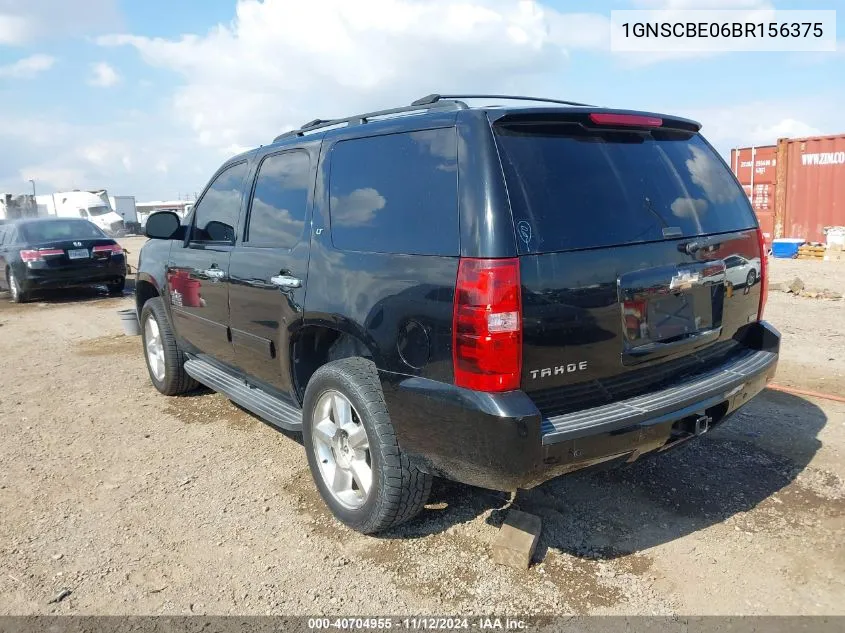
[0, 240, 845, 616]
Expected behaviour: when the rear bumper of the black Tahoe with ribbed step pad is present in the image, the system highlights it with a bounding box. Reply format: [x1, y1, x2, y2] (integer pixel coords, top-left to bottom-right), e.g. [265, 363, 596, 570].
[381, 322, 780, 490]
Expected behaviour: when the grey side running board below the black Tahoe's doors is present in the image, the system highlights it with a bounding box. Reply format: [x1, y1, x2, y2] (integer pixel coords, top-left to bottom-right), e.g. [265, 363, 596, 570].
[185, 358, 302, 431]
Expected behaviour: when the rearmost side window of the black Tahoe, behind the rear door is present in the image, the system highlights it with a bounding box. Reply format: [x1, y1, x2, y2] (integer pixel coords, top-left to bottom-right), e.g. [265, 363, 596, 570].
[330, 128, 459, 255]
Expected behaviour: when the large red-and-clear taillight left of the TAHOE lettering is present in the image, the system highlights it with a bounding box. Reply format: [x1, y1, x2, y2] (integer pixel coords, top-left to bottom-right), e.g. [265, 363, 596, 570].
[452, 258, 522, 391]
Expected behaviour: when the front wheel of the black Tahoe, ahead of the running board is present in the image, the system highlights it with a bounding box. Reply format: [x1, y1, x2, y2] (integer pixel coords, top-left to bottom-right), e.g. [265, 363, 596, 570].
[141, 297, 199, 396]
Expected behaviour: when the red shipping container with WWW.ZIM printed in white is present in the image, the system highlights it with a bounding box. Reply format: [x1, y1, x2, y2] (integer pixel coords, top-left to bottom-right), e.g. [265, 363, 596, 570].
[777, 134, 845, 242]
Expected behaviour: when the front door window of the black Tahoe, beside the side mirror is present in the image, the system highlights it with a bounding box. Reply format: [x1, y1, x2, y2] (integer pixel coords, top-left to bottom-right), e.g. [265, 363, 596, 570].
[191, 163, 247, 242]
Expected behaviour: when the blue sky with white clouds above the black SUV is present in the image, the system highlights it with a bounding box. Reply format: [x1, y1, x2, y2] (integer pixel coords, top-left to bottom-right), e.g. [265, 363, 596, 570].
[0, 0, 845, 202]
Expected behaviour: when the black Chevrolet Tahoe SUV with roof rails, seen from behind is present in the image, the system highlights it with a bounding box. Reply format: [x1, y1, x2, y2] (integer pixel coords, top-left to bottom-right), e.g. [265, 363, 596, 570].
[136, 95, 780, 532]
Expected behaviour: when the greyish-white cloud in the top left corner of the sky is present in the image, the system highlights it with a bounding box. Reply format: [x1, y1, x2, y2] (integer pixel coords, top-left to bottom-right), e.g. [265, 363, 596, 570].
[0, 0, 121, 46]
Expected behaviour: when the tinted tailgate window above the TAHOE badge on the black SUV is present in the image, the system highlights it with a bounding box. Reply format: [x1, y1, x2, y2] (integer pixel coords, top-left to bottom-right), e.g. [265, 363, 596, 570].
[495, 123, 756, 253]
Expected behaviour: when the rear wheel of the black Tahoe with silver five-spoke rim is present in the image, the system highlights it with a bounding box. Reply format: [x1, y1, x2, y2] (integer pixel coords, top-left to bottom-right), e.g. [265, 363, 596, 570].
[302, 358, 432, 534]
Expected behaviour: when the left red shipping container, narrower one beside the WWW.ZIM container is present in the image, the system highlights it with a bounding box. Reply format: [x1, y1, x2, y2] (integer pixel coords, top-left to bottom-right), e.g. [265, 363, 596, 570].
[731, 145, 777, 248]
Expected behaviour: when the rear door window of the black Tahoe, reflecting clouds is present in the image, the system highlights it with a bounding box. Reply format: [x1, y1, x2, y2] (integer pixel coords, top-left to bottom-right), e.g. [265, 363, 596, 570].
[247, 152, 311, 248]
